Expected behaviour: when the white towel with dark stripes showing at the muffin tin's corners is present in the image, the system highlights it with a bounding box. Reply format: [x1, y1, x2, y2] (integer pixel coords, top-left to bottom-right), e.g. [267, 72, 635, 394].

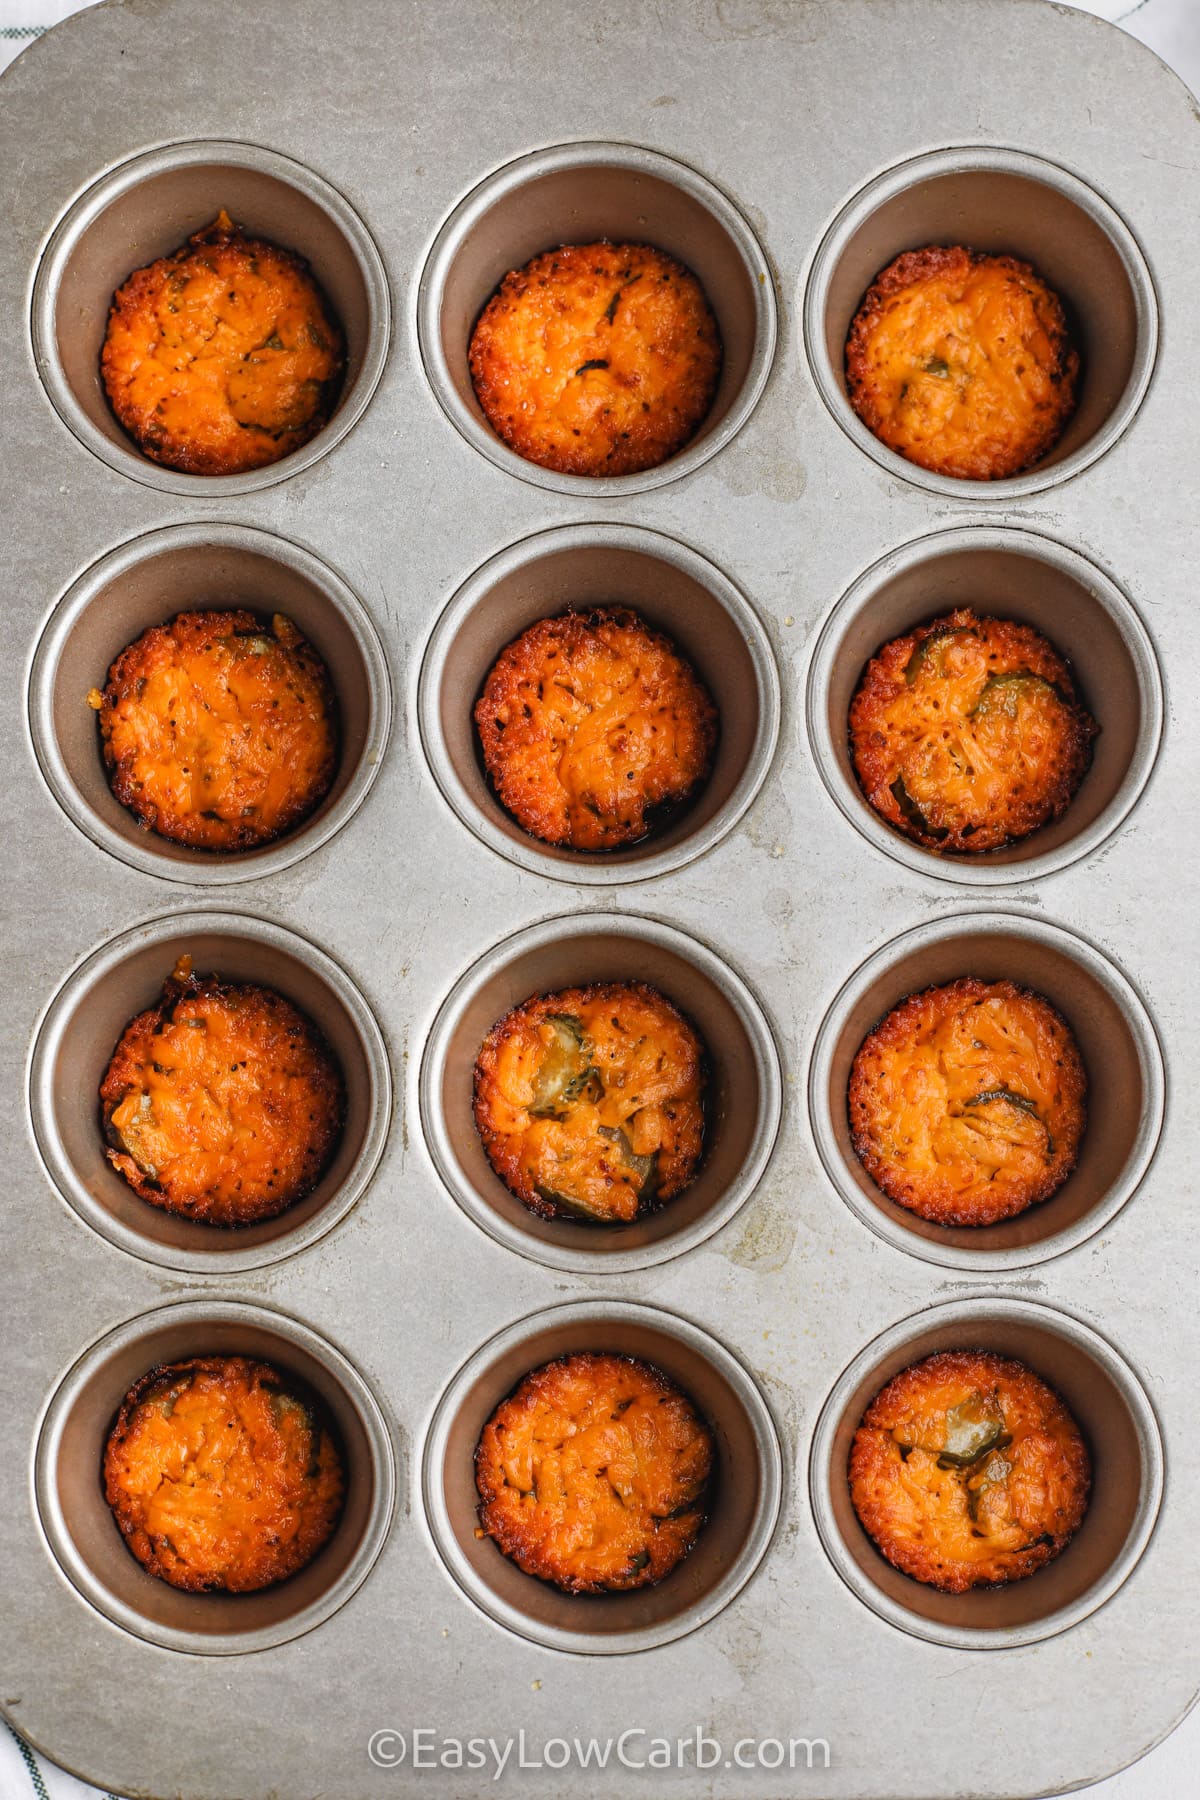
[0, 0, 1200, 1800]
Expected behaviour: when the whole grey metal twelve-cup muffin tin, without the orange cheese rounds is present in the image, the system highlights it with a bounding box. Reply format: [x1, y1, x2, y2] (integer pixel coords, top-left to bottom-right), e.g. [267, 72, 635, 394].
[0, 0, 1200, 1800]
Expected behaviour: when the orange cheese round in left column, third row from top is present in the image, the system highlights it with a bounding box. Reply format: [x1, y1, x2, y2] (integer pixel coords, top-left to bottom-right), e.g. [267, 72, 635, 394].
[101, 956, 345, 1226]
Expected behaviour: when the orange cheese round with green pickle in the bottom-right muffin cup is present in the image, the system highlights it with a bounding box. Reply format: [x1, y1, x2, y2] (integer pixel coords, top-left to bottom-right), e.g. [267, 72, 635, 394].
[849, 1350, 1092, 1593]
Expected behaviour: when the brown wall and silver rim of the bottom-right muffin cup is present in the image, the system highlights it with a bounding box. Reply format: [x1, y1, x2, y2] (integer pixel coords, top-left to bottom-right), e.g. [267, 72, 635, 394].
[810, 1294, 1162, 1651]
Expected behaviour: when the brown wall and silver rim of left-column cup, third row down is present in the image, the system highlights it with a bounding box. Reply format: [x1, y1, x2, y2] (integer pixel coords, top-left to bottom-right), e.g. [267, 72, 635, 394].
[29, 911, 392, 1276]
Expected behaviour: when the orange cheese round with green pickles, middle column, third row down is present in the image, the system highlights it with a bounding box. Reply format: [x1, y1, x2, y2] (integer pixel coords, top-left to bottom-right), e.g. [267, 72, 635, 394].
[475, 981, 705, 1224]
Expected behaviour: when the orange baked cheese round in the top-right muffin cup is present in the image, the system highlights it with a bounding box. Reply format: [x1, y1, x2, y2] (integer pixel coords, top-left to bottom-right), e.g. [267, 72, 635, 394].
[846, 245, 1079, 481]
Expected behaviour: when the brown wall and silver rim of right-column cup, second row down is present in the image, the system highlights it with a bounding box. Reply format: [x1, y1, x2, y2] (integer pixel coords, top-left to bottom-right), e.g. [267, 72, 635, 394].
[806, 526, 1162, 887]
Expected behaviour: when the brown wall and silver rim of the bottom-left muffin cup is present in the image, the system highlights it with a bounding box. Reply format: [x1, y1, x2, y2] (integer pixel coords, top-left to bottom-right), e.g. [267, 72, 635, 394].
[34, 1300, 396, 1656]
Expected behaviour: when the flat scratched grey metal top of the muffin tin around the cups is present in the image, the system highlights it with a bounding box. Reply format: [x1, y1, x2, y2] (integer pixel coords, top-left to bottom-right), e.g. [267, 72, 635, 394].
[0, 0, 1200, 1800]
